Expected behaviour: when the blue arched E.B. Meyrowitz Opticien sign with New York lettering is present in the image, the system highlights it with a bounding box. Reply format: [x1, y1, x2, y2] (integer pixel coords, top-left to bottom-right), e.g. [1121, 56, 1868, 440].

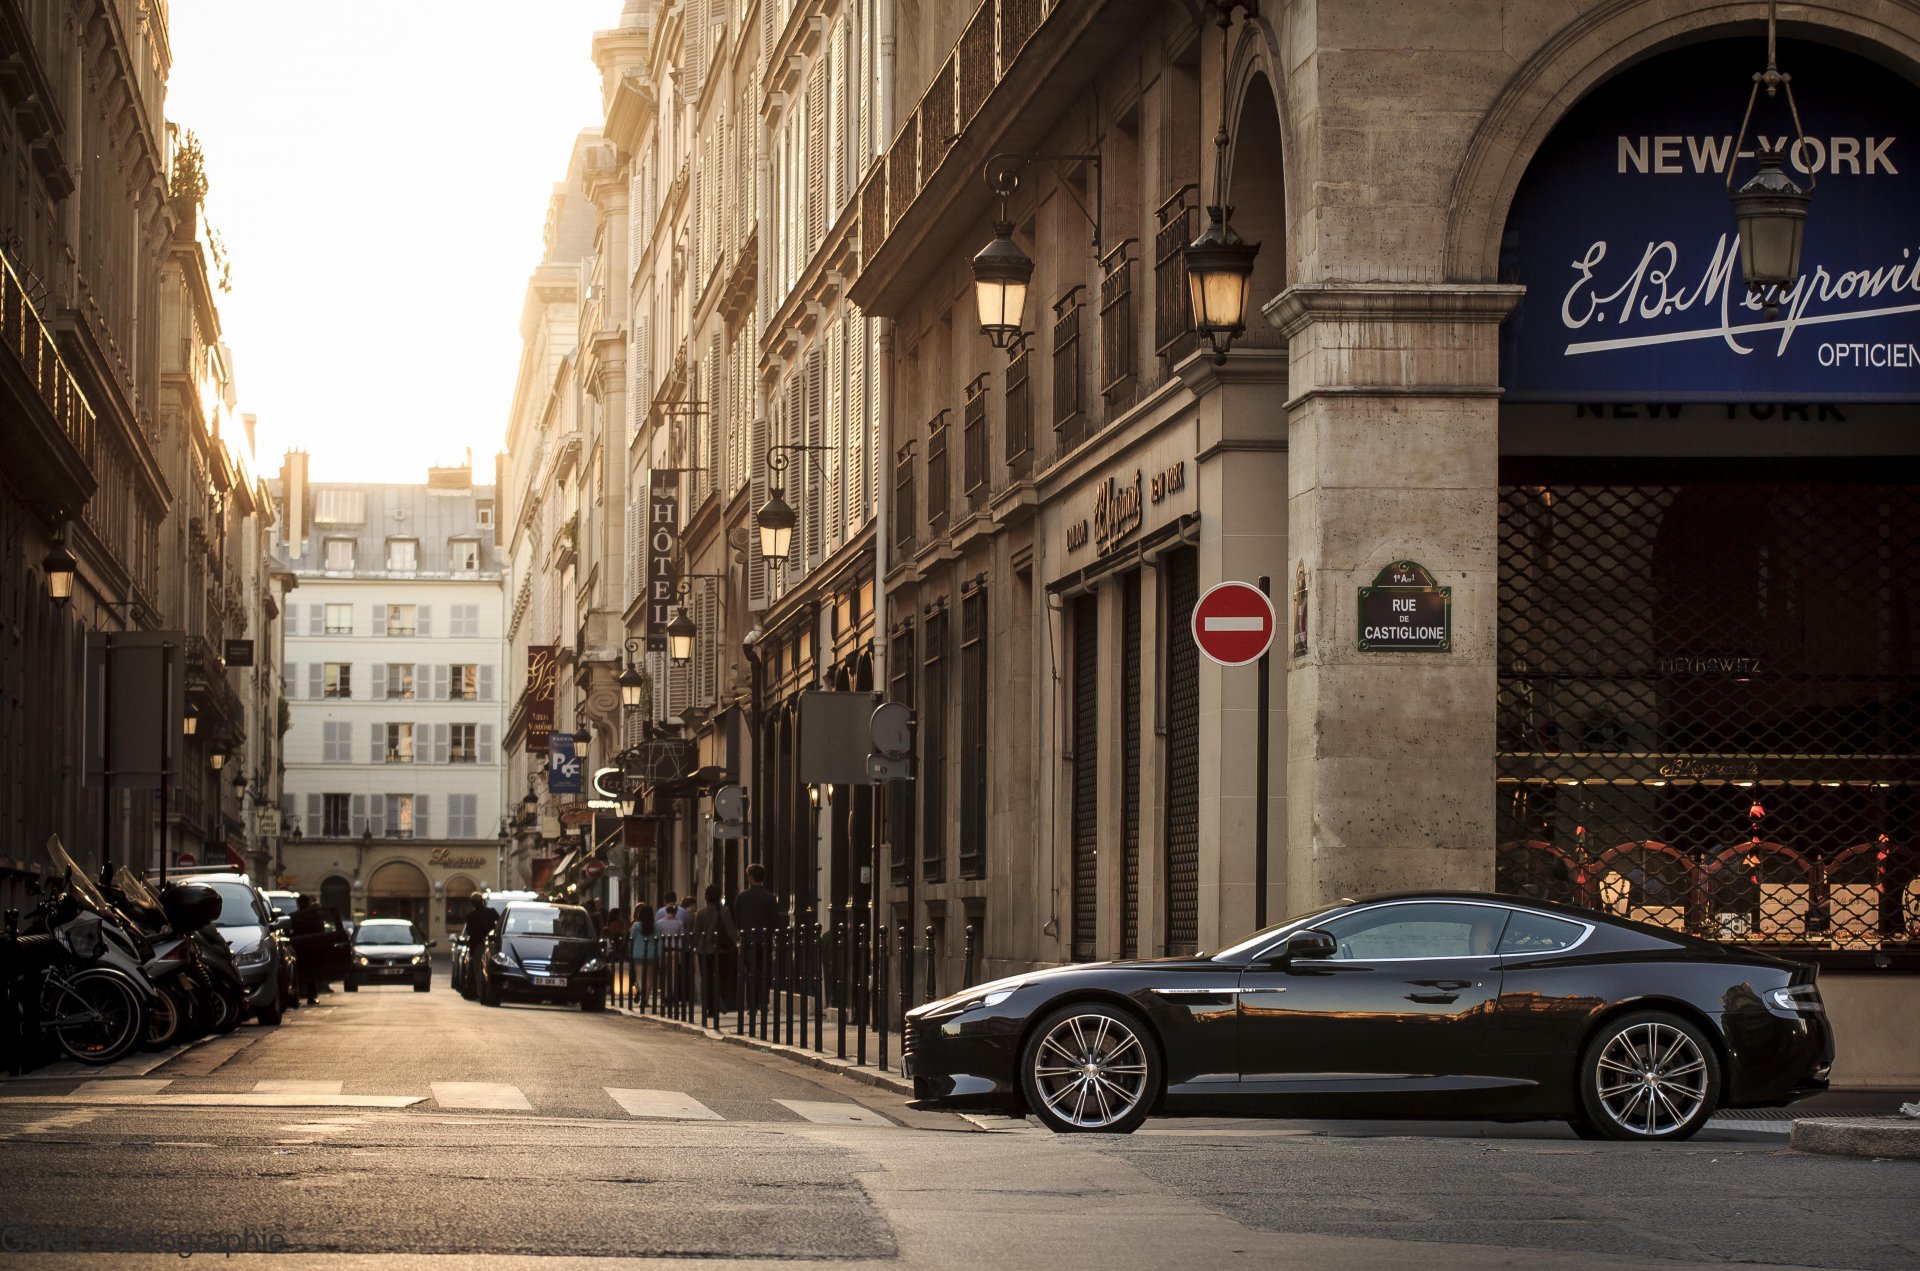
[1500, 35, 1920, 403]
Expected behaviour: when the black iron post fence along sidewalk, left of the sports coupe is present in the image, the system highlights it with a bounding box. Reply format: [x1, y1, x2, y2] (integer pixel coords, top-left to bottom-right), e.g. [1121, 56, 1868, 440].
[611, 910, 977, 1071]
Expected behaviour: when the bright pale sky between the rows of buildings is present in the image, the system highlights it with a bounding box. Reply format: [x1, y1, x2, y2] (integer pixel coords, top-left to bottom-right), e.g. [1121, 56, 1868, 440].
[167, 0, 622, 482]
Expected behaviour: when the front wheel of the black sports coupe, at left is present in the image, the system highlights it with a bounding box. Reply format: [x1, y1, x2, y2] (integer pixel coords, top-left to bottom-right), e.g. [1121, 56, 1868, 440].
[1020, 1002, 1162, 1135]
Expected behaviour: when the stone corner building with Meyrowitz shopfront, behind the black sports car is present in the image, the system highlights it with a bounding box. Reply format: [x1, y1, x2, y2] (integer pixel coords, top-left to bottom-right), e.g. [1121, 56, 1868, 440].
[847, 0, 1920, 1083]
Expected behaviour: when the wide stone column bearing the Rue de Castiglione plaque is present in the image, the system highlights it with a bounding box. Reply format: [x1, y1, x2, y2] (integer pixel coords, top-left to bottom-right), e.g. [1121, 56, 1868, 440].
[1267, 282, 1521, 912]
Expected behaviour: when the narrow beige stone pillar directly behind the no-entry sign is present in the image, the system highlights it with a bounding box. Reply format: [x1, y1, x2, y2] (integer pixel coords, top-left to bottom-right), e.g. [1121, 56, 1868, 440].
[1171, 349, 1288, 948]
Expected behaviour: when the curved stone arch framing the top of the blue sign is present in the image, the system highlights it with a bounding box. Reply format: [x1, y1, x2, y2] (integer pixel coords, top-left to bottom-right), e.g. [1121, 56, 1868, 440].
[1444, 0, 1920, 282]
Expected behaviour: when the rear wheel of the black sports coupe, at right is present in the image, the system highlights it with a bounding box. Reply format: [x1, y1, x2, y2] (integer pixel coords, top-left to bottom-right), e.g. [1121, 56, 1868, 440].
[1576, 1010, 1720, 1142]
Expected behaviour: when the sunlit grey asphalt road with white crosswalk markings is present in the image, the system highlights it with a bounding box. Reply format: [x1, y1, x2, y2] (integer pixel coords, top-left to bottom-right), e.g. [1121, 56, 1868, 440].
[0, 975, 1920, 1271]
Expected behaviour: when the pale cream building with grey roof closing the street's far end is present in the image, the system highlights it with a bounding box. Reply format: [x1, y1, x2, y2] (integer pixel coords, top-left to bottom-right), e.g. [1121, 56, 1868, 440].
[275, 462, 509, 952]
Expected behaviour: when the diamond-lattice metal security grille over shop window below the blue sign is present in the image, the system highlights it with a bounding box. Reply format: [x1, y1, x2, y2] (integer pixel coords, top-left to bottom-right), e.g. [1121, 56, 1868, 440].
[1496, 472, 1920, 960]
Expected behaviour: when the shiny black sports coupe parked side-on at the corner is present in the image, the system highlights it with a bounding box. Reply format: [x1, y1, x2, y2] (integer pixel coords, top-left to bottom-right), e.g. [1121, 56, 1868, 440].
[904, 893, 1834, 1140]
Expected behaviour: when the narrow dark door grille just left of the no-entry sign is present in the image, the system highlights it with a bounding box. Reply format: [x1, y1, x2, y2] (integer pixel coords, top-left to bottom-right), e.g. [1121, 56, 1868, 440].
[1162, 547, 1200, 954]
